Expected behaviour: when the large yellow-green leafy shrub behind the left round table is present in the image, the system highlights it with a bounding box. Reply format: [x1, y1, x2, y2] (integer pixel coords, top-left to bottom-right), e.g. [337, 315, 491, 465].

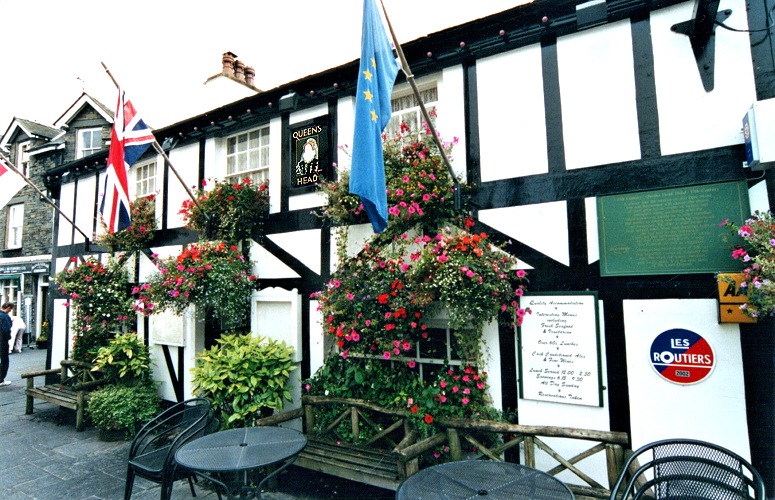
[191, 333, 296, 428]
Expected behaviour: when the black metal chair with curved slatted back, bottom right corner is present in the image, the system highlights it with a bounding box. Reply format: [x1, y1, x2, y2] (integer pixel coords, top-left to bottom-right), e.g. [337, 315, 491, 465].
[610, 439, 765, 500]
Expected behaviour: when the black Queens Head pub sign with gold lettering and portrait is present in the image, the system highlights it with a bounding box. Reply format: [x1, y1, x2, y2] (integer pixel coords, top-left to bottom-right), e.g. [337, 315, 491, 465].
[291, 118, 331, 190]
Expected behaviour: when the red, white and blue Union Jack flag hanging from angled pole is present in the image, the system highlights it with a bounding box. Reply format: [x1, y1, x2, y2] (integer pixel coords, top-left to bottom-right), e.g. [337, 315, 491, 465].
[100, 89, 156, 233]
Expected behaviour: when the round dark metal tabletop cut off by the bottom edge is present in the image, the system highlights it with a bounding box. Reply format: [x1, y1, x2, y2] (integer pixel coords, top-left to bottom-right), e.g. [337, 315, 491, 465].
[396, 460, 574, 500]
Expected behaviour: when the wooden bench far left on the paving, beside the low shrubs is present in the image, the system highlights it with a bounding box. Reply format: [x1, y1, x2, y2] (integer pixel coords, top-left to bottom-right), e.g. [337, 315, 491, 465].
[22, 359, 105, 432]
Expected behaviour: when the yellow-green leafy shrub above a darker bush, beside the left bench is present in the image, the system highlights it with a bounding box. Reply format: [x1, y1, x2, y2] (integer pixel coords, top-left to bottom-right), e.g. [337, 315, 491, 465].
[94, 333, 153, 386]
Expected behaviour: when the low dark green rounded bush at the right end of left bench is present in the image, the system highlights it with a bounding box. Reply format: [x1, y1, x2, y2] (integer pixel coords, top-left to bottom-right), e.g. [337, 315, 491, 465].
[87, 385, 160, 439]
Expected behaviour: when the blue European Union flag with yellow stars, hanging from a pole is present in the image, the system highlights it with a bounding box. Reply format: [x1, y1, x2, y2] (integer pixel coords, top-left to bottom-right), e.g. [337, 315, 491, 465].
[350, 0, 398, 233]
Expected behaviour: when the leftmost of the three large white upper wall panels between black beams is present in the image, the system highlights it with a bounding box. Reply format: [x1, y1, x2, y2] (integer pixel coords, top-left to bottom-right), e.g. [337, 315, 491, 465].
[476, 44, 549, 182]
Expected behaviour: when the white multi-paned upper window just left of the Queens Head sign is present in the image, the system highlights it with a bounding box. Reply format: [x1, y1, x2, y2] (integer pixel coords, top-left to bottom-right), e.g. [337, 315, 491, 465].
[226, 127, 269, 183]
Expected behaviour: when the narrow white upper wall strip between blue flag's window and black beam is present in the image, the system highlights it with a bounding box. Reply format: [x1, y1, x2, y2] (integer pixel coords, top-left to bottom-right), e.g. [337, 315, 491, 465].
[436, 66, 466, 182]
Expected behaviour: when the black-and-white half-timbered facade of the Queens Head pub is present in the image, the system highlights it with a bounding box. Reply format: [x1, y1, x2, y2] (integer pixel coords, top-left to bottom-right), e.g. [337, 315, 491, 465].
[44, 0, 775, 489]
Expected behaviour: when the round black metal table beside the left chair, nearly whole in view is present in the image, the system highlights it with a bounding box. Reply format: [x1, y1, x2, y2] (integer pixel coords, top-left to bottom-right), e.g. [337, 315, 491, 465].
[175, 427, 307, 499]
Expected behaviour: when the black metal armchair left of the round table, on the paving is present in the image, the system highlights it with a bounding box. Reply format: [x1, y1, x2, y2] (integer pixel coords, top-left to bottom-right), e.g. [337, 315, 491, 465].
[124, 398, 219, 500]
